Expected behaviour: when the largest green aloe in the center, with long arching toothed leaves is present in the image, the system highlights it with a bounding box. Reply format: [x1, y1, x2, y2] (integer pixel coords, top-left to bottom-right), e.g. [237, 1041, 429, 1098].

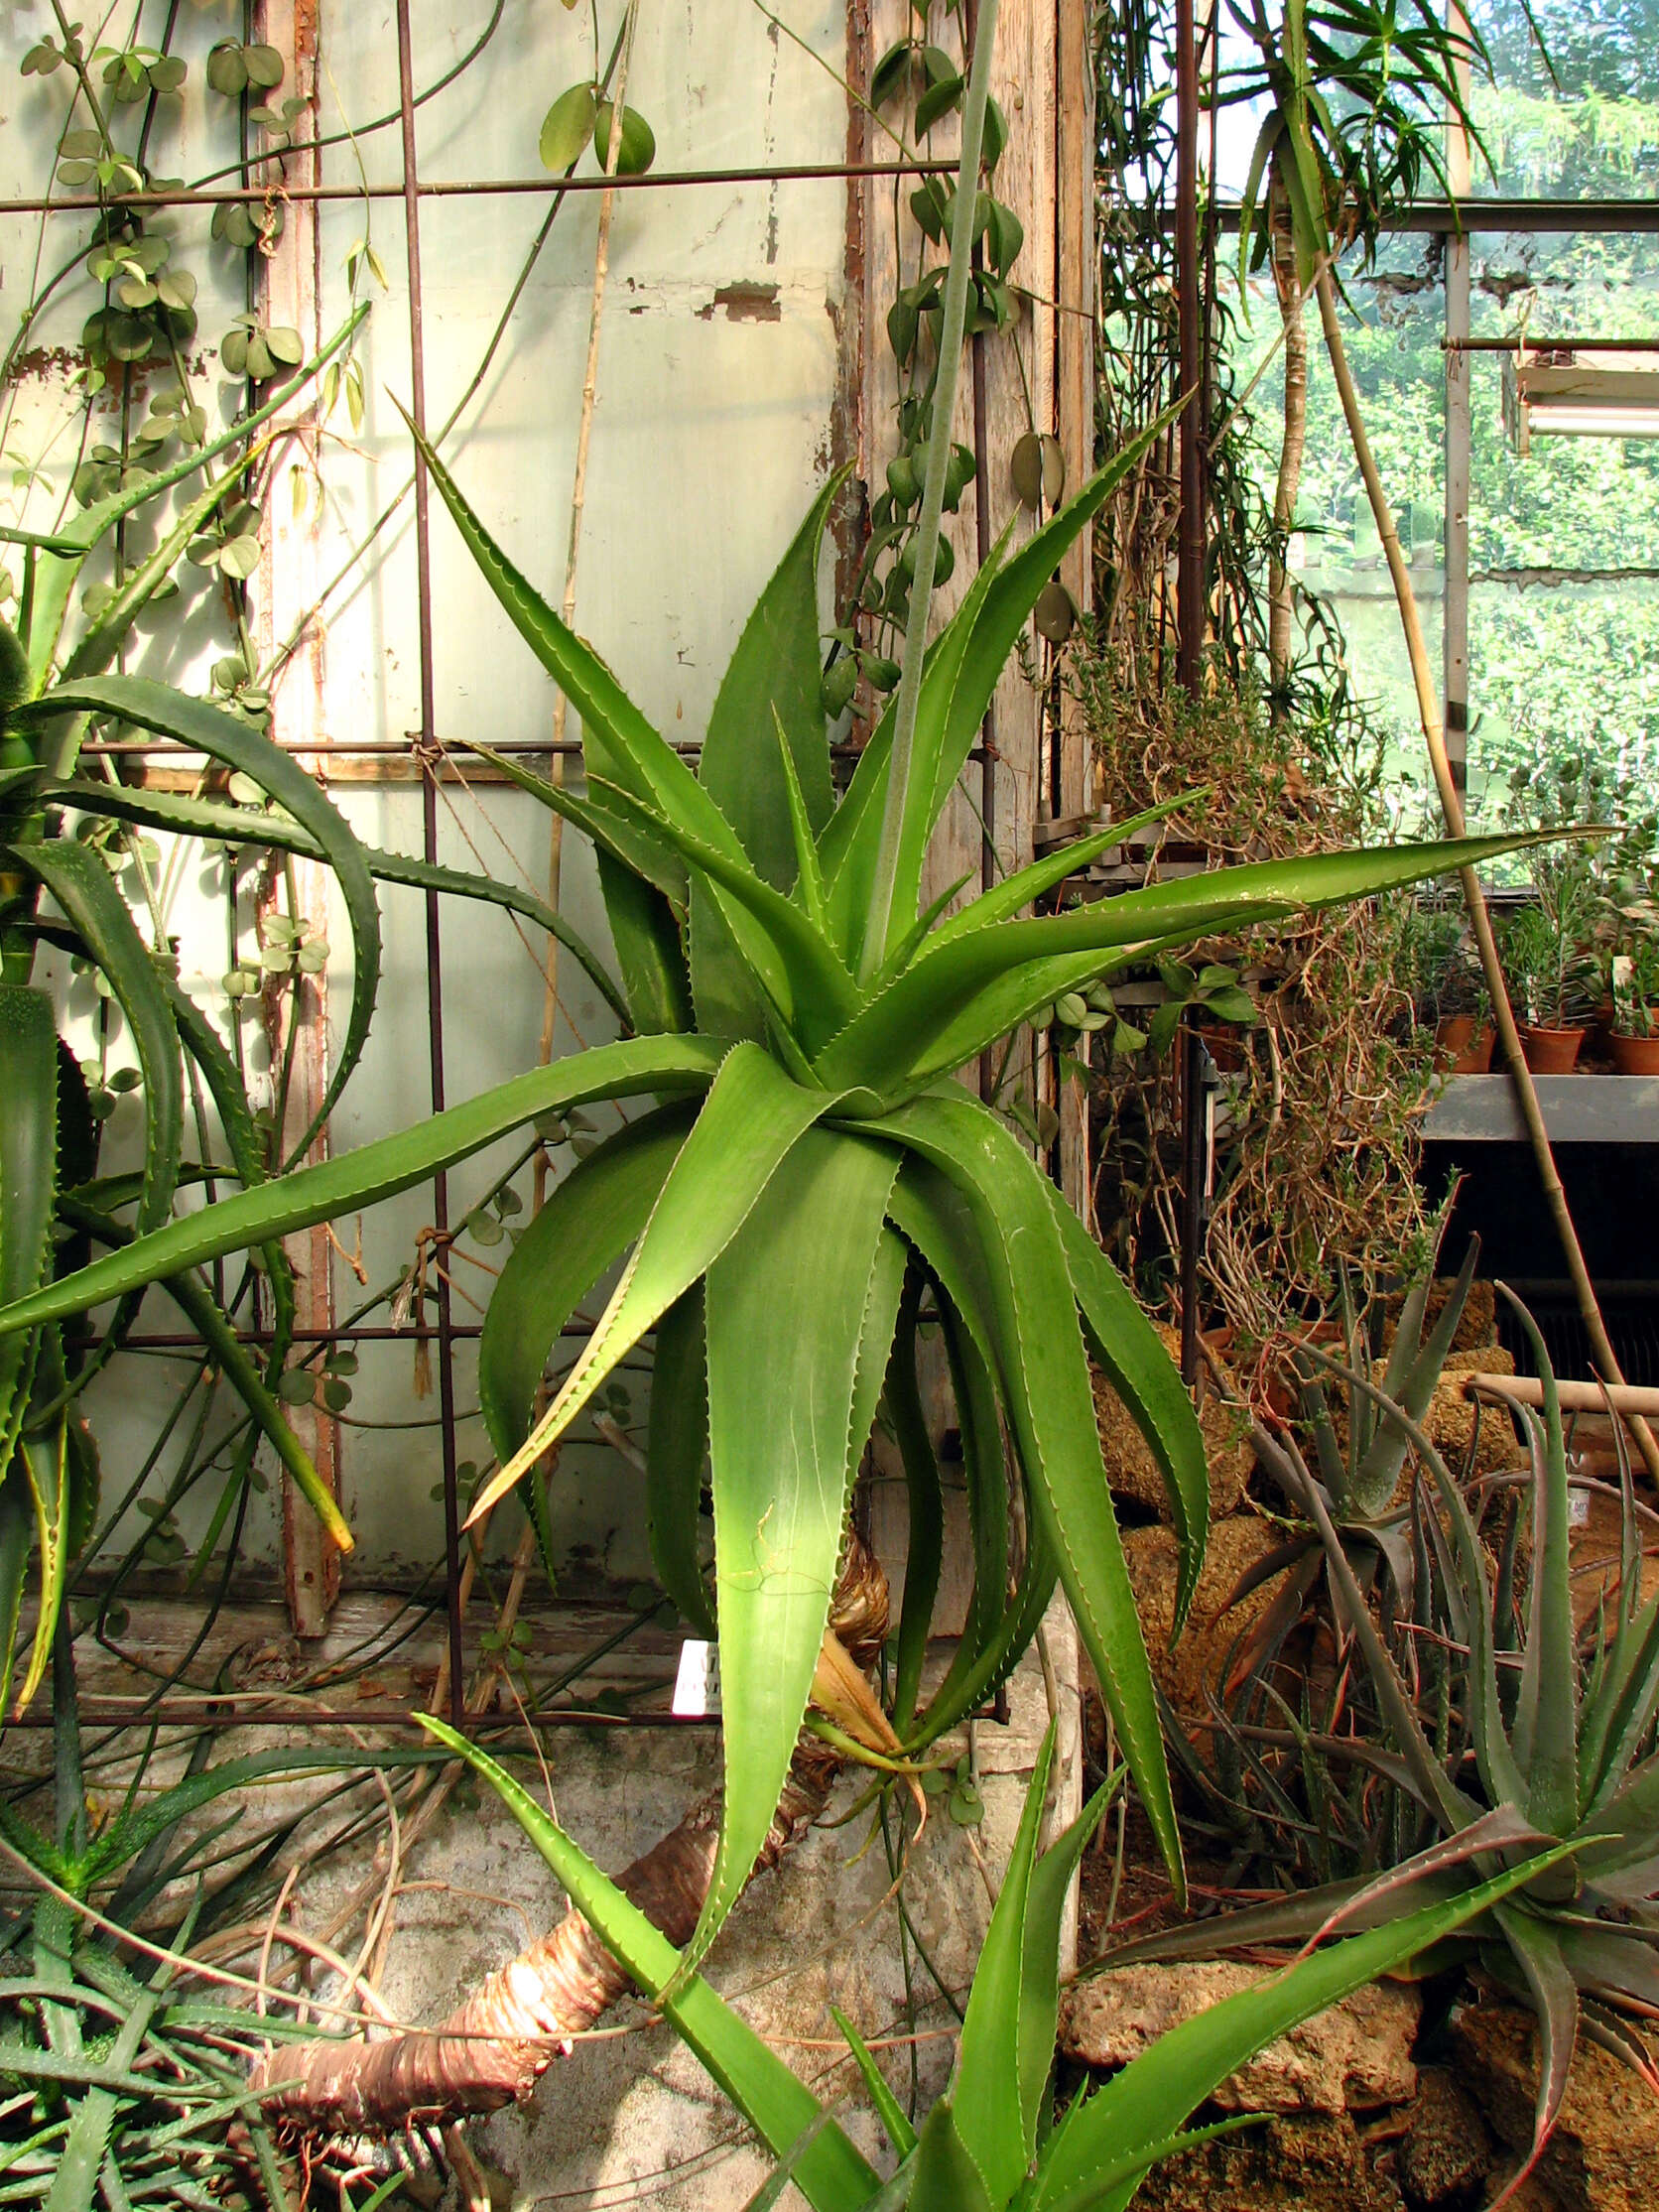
[0, 4, 1557, 1962]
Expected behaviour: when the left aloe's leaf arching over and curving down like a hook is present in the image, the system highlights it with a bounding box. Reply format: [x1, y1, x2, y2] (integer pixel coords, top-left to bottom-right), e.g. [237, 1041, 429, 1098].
[29, 677, 380, 1159]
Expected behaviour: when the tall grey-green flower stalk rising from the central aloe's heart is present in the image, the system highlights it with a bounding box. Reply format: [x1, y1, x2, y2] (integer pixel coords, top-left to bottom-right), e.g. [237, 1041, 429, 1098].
[860, 0, 997, 982]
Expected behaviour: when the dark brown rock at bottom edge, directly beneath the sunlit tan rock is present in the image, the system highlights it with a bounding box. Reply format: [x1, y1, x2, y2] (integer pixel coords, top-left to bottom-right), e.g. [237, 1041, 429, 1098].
[1119, 2113, 1402, 2212]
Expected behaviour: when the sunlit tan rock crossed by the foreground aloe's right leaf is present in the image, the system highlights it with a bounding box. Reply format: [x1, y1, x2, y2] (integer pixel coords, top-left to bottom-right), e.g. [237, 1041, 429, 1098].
[1060, 1958, 1418, 2113]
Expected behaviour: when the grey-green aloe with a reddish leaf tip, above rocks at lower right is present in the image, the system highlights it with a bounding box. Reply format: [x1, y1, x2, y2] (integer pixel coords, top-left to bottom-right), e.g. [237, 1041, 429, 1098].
[1103, 1285, 1659, 2159]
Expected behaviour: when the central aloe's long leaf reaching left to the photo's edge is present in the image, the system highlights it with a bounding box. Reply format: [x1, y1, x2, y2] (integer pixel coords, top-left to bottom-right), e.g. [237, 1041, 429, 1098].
[0, 1037, 721, 1332]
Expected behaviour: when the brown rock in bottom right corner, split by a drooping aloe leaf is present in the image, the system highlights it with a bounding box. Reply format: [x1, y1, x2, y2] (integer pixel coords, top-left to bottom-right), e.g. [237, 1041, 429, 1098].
[1451, 2004, 1659, 2212]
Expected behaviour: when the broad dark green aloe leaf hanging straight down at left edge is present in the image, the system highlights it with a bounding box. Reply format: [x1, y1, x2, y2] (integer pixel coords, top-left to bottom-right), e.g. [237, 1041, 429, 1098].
[0, 984, 58, 1451]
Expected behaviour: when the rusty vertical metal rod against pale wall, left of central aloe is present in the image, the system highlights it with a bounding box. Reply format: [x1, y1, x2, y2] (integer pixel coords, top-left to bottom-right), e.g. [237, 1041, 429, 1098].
[398, 0, 466, 1728]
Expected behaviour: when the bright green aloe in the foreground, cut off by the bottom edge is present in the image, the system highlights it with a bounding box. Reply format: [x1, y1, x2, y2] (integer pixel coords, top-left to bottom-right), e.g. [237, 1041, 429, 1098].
[423, 1717, 1560, 2212]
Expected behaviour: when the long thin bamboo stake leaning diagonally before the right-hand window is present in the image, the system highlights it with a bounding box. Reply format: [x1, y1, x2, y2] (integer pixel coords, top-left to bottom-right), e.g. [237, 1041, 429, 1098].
[1316, 268, 1659, 1482]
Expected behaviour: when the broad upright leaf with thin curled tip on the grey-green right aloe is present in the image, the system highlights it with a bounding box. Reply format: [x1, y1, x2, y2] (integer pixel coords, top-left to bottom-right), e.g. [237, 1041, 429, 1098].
[1504, 1287, 1580, 1836]
